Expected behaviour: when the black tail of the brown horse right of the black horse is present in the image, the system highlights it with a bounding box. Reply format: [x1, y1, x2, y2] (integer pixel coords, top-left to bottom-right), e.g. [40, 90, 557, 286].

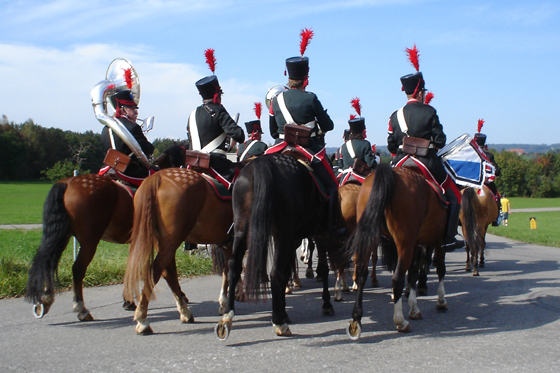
[347, 164, 395, 270]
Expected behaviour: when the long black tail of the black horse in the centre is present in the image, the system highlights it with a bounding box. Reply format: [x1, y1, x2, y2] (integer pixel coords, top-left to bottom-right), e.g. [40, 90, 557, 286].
[245, 158, 274, 301]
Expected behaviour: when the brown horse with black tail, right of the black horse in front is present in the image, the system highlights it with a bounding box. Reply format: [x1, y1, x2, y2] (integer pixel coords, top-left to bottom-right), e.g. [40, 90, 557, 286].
[346, 164, 447, 339]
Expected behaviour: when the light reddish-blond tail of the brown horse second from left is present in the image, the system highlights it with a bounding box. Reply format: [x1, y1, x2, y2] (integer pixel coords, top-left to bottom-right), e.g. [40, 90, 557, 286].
[123, 173, 161, 302]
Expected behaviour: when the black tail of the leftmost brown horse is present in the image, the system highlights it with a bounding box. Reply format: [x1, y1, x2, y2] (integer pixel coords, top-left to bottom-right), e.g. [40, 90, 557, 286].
[25, 182, 72, 303]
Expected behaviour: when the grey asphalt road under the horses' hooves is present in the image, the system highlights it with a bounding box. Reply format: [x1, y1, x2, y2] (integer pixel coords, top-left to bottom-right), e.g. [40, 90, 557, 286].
[0, 236, 560, 373]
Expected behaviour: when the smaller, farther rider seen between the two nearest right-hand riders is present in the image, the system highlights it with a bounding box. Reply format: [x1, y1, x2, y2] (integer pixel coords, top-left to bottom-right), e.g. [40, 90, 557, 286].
[338, 98, 377, 185]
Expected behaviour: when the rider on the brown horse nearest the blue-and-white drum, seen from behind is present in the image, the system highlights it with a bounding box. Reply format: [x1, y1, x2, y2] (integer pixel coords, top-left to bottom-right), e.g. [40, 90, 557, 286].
[387, 45, 461, 251]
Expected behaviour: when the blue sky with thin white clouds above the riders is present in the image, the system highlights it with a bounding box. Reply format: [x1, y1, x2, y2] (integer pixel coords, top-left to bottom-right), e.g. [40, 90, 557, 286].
[0, 0, 560, 147]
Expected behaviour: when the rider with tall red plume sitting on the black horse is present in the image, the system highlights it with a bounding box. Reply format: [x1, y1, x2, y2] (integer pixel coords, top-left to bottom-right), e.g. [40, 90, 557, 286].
[265, 29, 343, 234]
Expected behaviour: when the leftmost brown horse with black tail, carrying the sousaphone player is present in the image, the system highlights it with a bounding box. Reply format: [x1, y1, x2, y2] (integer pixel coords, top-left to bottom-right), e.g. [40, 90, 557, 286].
[26, 146, 184, 321]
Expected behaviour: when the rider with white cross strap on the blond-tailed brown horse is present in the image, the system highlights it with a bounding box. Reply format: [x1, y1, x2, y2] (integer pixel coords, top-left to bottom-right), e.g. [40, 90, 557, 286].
[187, 49, 245, 189]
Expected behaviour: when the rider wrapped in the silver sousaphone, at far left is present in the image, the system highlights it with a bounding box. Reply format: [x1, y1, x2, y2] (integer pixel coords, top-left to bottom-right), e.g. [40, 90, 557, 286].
[101, 90, 154, 178]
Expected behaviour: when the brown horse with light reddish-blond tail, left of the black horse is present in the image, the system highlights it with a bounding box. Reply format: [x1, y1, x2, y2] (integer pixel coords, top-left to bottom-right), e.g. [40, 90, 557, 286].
[124, 168, 233, 334]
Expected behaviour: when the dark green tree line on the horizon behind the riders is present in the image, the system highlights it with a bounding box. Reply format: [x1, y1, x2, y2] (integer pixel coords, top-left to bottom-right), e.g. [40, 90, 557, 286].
[0, 116, 560, 198]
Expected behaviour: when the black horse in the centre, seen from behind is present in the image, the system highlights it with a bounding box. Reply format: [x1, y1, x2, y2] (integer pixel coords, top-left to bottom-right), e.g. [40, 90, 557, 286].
[215, 153, 342, 340]
